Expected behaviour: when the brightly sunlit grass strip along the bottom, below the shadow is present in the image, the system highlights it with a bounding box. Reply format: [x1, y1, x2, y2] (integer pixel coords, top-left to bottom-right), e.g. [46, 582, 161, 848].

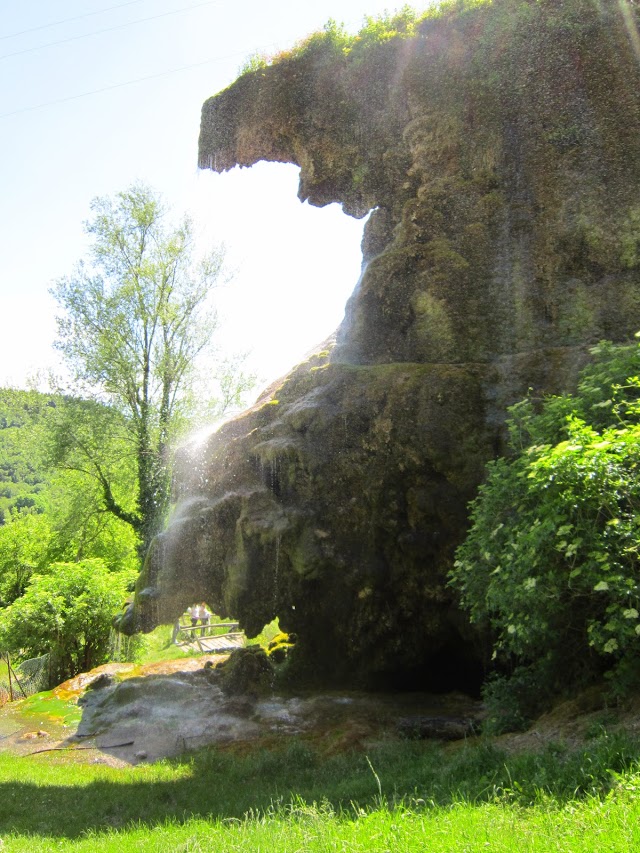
[5, 798, 640, 853]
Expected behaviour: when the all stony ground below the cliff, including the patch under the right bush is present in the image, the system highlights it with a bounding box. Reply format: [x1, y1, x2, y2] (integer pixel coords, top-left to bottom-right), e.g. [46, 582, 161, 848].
[0, 655, 640, 766]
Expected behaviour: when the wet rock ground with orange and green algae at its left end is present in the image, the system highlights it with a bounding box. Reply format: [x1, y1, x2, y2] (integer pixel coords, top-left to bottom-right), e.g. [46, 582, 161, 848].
[0, 662, 482, 765]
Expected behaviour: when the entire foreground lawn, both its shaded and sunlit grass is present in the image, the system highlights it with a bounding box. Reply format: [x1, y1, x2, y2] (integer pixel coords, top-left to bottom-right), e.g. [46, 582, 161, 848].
[0, 733, 640, 853]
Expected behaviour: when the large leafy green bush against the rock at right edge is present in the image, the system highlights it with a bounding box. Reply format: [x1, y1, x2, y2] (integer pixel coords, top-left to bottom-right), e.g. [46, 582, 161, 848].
[451, 336, 640, 712]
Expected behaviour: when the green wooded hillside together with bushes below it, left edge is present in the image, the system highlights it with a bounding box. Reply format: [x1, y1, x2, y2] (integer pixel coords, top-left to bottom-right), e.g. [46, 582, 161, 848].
[0, 388, 139, 683]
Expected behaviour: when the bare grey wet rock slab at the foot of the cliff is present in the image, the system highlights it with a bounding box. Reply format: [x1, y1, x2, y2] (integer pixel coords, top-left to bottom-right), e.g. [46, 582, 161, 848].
[75, 672, 480, 763]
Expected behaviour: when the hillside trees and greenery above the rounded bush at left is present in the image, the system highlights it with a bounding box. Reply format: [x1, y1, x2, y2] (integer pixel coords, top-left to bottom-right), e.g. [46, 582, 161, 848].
[0, 389, 137, 607]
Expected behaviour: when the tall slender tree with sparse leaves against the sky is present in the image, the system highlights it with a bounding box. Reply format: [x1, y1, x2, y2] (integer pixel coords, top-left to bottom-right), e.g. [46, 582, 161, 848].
[52, 185, 252, 553]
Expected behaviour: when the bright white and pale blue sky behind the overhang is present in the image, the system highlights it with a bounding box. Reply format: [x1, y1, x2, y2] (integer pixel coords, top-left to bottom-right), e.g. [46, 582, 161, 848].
[0, 0, 424, 392]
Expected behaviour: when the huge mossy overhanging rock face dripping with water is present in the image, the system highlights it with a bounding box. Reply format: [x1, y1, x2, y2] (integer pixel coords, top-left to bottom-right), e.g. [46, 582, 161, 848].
[119, 0, 640, 689]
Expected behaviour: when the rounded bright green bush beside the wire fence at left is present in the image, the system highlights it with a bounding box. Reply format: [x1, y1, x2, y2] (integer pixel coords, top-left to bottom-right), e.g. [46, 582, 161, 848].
[0, 559, 134, 684]
